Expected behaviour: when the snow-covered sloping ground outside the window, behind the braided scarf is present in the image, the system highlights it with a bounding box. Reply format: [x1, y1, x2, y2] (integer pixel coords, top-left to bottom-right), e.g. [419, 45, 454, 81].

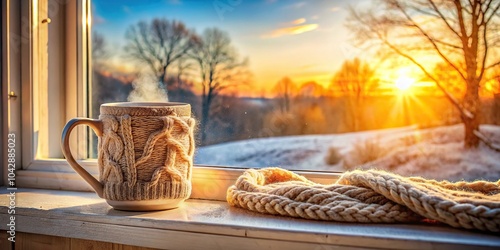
[195, 125, 500, 181]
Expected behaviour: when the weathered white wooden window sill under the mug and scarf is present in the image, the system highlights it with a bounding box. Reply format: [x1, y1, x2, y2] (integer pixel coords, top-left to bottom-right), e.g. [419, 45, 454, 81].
[0, 187, 500, 249]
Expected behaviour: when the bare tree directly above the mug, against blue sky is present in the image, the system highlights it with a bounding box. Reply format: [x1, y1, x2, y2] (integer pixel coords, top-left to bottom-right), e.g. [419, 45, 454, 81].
[125, 18, 199, 89]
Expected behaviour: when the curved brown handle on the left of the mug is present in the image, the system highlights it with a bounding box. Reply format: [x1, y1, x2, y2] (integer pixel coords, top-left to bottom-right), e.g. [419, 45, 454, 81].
[61, 118, 103, 198]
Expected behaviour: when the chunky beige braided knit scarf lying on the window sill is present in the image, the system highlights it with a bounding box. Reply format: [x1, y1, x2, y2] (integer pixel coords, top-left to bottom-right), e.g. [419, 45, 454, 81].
[227, 168, 500, 232]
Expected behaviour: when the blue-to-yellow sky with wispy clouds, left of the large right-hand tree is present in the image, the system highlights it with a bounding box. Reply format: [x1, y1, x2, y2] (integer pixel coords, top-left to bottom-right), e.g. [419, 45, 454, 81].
[92, 0, 386, 96]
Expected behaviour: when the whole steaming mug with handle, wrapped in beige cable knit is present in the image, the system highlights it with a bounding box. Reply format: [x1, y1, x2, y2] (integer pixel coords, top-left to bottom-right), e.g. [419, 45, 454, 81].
[61, 102, 195, 211]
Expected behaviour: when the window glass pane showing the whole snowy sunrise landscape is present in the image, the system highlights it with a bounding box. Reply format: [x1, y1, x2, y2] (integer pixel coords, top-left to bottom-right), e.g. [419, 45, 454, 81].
[92, 0, 500, 180]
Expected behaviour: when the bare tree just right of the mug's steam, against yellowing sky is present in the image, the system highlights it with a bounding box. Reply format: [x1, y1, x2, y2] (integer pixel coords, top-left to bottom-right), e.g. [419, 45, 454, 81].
[190, 28, 250, 143]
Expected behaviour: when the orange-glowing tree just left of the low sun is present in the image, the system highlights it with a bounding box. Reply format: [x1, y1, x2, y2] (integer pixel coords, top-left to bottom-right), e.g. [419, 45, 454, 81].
[330, 58, 379, 131]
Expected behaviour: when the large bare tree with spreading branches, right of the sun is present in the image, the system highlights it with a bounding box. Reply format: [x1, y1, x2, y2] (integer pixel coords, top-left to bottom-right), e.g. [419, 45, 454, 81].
[348, 0, 500, 148]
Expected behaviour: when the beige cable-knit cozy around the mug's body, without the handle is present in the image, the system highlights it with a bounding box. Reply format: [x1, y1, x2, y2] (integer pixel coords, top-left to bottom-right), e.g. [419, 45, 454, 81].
[98, 105, 195, 201]
